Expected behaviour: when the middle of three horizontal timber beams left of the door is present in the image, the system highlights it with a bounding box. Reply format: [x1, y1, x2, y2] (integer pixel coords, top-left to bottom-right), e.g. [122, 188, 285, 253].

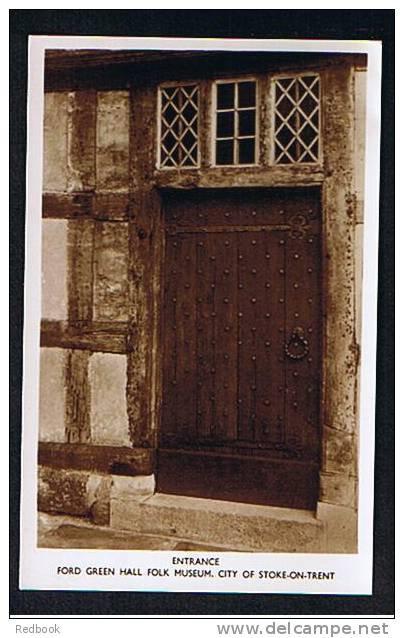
[41, 320, 132, 354]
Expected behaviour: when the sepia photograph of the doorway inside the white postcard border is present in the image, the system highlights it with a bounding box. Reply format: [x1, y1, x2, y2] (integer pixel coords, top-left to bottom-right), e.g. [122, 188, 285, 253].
[15, 31, 380, 600]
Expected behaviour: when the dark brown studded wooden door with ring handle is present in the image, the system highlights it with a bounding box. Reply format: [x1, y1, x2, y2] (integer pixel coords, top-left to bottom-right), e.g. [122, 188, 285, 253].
[157, 188, 322, 508]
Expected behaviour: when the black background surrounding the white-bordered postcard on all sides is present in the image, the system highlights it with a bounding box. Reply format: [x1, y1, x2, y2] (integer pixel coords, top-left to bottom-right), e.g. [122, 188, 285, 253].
[10, 9, 394, 617]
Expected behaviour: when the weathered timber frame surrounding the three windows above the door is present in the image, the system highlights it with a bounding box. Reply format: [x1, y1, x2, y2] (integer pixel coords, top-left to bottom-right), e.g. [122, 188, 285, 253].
[155, 72, 325, 180]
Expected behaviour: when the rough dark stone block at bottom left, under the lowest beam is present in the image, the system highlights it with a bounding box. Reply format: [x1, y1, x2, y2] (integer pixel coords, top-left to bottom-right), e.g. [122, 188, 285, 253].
[38, 467, 88, 516]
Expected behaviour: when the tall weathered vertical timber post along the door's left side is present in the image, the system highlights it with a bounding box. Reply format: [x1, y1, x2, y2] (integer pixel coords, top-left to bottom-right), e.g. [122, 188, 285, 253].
[127, 86, 162, 447]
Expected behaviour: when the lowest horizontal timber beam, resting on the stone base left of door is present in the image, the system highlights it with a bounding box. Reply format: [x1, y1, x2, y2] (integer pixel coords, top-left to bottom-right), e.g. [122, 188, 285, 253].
[38, 442, 155, 476]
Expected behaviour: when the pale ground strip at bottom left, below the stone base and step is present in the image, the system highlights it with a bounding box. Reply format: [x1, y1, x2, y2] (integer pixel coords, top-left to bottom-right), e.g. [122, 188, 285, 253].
[38, 512, 231, 552]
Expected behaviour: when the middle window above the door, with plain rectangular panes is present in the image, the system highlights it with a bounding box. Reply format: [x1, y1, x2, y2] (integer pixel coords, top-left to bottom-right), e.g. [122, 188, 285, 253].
[214, 80, 258, 166]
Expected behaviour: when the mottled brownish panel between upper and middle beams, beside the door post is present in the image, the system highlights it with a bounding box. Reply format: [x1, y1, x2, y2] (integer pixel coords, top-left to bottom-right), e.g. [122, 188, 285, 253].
[94, 222, 129, 321]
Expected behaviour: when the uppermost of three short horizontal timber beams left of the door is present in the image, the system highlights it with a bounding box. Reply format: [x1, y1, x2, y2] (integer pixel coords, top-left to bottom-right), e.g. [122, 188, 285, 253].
[42, 192, 131, 221]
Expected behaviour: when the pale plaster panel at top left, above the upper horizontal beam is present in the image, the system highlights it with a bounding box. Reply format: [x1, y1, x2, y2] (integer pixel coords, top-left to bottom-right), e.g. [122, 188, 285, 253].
[43, 92, 68, 192]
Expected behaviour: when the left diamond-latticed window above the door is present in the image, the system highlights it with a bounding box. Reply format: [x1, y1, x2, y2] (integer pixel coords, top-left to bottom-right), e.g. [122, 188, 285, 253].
[159, 85, 199, 168]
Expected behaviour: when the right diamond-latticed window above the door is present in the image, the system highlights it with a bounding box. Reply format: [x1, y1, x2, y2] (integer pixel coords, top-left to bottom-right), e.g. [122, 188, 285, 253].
[274, 75, 321, 164]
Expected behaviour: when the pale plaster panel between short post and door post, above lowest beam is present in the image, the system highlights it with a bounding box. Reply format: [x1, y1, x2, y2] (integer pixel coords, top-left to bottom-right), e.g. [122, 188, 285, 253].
[89, 352, 131, 447]
